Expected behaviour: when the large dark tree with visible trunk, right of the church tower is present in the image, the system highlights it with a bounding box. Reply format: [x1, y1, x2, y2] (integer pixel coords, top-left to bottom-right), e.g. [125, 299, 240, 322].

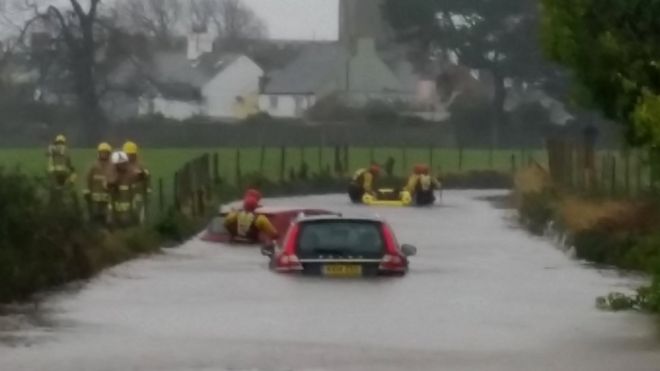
[383, 0, 551, 145]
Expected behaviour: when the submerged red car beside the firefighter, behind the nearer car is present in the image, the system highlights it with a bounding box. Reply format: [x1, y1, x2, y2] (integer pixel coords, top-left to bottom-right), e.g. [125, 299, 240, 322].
[201, 206, 336, 244]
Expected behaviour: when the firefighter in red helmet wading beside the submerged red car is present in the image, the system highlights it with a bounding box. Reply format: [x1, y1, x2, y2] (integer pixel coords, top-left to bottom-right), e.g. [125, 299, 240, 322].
[224, 196, 278, 242]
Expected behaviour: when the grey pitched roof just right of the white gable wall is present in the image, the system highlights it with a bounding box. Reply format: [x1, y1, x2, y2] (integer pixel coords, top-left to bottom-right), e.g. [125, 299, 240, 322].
[264, 43, 348, 94]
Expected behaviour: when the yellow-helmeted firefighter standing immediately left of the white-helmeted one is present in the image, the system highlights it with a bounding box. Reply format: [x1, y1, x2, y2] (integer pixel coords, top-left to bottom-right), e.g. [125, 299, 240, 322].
[83, 143, 113, 224]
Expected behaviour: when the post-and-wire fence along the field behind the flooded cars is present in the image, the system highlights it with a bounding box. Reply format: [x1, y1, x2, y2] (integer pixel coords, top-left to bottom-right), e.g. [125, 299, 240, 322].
[151, 145, 546, 221]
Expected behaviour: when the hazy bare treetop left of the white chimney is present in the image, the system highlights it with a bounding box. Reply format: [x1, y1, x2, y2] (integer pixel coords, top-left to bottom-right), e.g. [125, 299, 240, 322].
[117, 0, 186, 46]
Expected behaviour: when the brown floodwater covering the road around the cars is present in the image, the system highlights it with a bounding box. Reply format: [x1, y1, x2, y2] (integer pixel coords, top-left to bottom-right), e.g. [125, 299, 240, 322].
[0, 192, 660, 371]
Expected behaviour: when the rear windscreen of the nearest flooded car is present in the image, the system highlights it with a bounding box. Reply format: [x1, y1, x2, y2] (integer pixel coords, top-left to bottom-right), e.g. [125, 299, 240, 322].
[298, 220, 385, 257]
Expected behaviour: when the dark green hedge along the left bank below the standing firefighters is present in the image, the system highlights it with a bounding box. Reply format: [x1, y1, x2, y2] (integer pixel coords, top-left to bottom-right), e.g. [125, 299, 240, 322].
[0, 168, 160, 302]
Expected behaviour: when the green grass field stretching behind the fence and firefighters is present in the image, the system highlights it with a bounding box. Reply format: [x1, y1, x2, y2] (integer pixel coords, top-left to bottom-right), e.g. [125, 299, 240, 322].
[0, 147, 544, 217]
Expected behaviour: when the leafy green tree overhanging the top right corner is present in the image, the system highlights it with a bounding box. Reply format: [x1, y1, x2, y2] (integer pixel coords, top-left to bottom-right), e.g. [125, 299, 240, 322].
[542, 0, 660, 146]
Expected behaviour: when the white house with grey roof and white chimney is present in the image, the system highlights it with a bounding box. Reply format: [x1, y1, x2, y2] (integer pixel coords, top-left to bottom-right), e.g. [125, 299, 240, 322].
[138, 51, 263, 120]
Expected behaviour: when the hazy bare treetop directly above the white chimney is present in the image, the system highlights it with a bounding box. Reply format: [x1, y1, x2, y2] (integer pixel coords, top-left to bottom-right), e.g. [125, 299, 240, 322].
[191, 0, 267, 47]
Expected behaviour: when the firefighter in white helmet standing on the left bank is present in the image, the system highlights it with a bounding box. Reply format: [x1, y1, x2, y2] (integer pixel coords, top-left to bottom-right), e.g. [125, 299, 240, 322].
[108, 151, 138, 228]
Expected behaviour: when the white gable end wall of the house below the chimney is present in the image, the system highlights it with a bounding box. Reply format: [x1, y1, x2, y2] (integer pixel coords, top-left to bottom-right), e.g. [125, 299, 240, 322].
[202, 56, 264, 117]
